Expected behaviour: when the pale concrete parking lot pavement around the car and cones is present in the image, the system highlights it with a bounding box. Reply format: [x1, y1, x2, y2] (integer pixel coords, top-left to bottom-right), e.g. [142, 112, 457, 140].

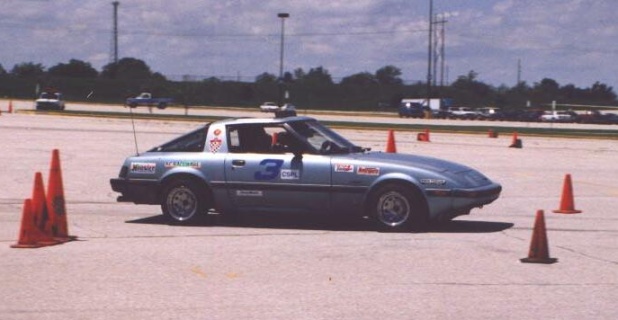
[0, 109, 618, 319]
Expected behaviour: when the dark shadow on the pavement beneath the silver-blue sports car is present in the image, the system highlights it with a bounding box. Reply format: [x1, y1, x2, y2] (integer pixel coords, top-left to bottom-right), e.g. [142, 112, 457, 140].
[125, 213, 514, 233]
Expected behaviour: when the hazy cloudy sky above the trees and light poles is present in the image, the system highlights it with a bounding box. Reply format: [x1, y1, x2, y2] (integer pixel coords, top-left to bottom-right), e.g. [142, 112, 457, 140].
[0, 0, 618, 88]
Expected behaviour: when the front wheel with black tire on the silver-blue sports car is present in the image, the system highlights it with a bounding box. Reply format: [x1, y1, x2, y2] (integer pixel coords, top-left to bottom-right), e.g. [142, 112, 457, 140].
[367, 183, 428, 231]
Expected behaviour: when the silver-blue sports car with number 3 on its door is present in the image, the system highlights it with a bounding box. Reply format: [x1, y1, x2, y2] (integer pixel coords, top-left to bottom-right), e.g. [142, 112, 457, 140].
[110, 117, 502, 230]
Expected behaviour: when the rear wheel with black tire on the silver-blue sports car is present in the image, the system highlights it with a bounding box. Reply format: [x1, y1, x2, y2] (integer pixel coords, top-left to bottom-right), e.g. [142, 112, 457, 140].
[161, 179, 208, 223]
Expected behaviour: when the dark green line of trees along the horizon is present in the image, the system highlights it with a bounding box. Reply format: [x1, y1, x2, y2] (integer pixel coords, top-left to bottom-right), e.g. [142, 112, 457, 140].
[0, 58, 618, 110]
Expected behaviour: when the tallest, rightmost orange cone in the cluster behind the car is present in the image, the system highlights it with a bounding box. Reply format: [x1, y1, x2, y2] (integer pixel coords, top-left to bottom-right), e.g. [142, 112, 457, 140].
[45, 149, 77, 241]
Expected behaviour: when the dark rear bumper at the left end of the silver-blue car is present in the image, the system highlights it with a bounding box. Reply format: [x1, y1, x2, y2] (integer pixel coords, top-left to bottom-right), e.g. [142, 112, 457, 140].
[109, 178, 160, 204]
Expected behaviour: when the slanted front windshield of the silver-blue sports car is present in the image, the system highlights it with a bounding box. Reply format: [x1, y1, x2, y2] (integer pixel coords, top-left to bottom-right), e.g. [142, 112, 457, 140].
[289, 121, 364, 154]
